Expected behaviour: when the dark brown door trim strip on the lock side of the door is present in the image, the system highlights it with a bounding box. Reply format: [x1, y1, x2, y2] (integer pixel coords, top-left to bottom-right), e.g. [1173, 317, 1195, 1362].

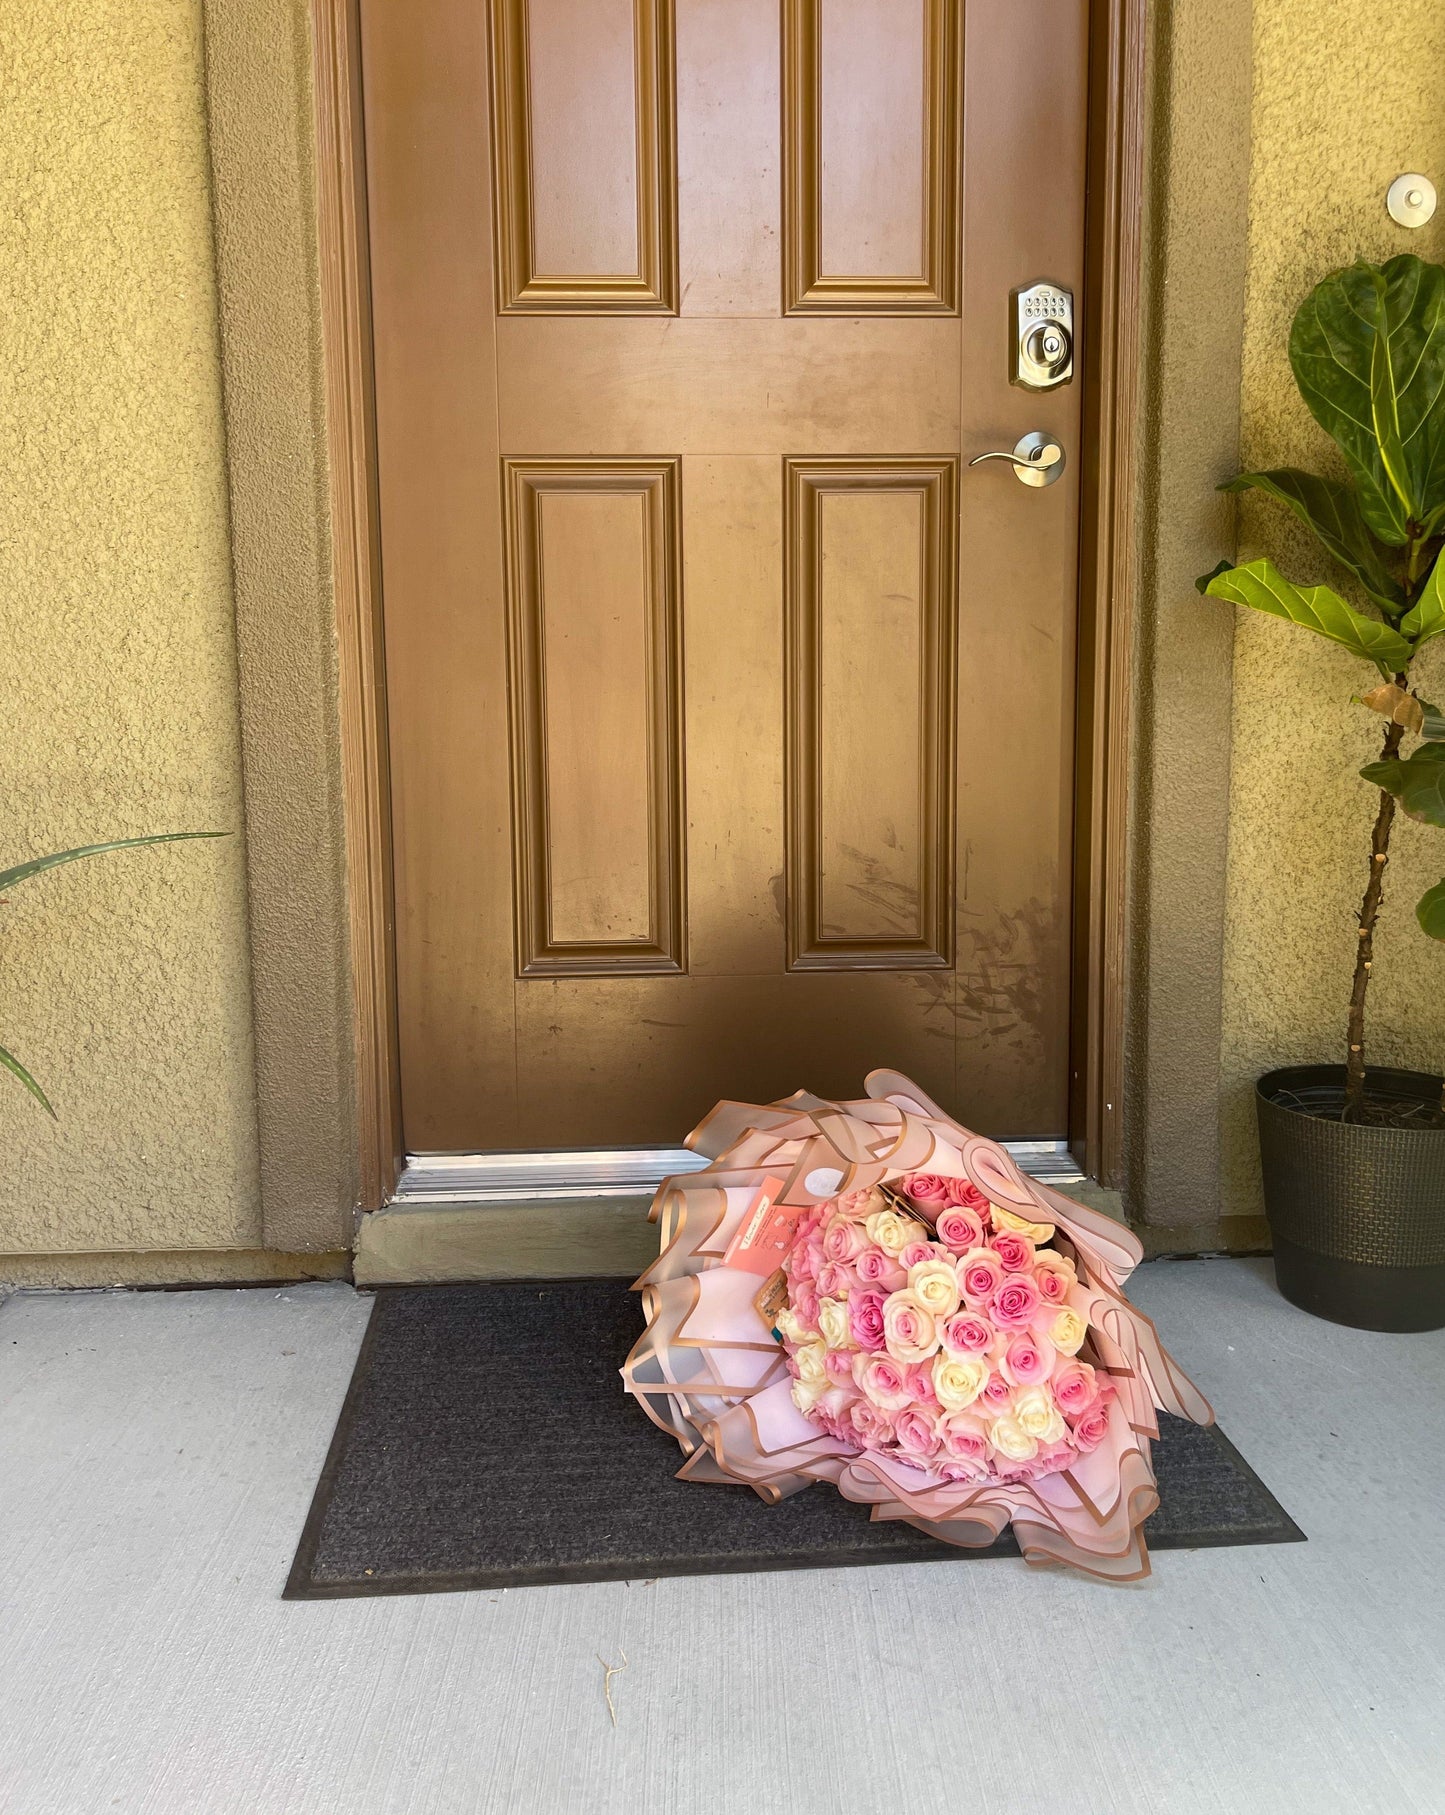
[1069, 0, 1147, 1187]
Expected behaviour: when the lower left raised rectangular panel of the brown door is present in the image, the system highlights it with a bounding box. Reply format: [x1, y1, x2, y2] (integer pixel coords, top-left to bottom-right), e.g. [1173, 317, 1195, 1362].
[505, 461, 684, 976]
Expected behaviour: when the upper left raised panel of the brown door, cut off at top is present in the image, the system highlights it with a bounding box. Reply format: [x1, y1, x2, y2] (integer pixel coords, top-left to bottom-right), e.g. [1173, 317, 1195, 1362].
[492, 0, 677, 314]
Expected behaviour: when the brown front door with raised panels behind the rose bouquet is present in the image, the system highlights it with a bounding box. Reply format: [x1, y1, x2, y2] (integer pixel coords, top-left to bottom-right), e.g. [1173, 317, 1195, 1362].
[363, 0, 1087, 1151]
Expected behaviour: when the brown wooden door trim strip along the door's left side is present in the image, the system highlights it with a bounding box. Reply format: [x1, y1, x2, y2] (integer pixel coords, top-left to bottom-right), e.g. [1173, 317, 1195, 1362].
[310, 0, 403, 1211]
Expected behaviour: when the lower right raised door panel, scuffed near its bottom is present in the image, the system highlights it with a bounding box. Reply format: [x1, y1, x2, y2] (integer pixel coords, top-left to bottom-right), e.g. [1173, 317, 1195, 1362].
[786, 459, 957, 971]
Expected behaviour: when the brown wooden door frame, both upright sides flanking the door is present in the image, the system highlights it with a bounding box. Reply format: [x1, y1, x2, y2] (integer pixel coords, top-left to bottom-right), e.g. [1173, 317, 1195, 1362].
[309, 0, 1147, 1211]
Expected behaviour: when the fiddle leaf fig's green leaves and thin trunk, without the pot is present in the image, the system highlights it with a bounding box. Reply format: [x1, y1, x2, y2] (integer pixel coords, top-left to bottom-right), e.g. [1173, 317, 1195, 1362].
[1198, 252, 1445, 1120]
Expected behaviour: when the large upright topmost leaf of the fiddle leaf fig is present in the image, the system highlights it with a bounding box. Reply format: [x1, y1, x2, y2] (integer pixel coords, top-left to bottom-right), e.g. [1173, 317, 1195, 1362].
[1289, 252, 1445, 546]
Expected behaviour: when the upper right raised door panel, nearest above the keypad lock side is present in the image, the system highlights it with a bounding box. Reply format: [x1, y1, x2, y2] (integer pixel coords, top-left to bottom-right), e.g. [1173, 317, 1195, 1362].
[782, 0, 958, 316]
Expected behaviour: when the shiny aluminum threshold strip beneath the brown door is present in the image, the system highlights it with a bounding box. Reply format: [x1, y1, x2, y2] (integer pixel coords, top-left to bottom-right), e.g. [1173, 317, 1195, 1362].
[392, 1140, 1084, 1207]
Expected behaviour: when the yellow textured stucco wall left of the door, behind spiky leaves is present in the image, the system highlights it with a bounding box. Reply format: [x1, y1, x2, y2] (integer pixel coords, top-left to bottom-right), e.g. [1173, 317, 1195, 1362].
[0, 0, 261, 1254]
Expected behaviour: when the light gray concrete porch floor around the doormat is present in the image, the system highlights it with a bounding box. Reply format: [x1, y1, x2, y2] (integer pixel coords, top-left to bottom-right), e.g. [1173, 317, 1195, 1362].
[0, 1260, 1445, 1815]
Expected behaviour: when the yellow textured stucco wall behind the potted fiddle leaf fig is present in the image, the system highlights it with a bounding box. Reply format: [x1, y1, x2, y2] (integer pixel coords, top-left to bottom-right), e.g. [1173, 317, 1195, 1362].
[1224, 0, 1445, 1214]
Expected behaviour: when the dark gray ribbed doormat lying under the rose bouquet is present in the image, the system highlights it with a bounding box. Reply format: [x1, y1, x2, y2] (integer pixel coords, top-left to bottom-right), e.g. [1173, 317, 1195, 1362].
[285, 1280, 1305, 1601]
